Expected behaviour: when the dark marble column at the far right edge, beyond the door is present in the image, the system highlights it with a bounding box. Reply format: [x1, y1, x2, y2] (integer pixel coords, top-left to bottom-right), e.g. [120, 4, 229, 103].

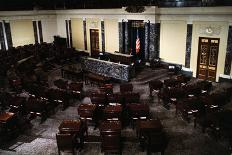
[224, 26, 232, 75]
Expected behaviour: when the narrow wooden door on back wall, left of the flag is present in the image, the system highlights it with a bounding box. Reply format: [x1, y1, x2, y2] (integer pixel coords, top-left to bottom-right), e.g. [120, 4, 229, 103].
[90, 29, 99, 57]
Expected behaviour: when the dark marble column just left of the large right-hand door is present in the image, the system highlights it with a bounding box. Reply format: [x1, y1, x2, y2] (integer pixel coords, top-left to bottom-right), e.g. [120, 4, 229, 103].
[185, 24, 193, 68]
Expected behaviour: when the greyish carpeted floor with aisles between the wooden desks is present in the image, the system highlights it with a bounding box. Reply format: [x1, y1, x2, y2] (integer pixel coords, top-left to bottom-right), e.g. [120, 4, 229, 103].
[0, 65, 232, 155]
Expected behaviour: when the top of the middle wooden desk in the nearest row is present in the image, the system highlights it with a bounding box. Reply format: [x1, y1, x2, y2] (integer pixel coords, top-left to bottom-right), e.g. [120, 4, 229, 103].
[99, 121, 122, 133]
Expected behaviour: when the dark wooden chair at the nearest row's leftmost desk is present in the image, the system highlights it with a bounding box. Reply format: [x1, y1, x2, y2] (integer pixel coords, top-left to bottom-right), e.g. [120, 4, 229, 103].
[56, 133, 76, 155]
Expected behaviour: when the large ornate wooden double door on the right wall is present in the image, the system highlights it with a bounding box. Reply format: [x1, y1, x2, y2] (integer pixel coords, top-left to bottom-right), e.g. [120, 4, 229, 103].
[197, 37, 219, 81]
